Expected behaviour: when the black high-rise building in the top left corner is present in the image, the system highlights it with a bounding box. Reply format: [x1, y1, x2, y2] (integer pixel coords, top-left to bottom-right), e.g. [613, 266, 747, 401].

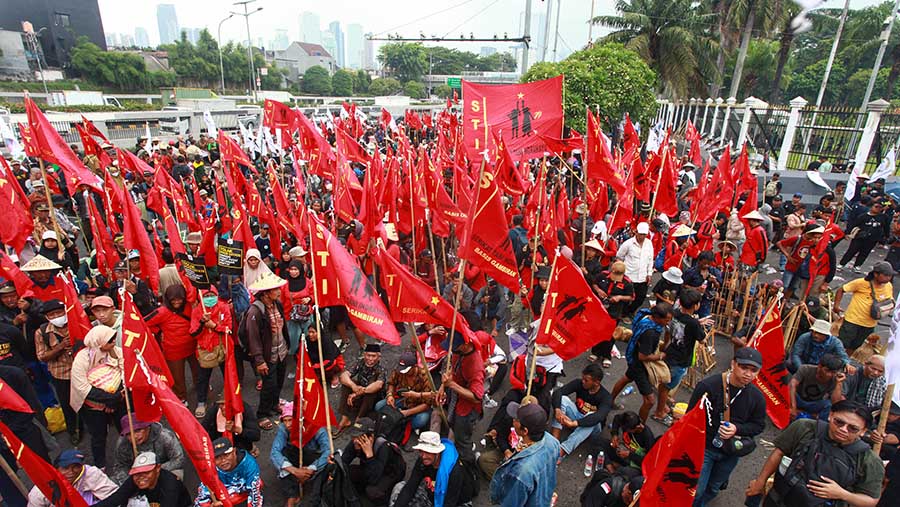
[0, 0, 106, 67]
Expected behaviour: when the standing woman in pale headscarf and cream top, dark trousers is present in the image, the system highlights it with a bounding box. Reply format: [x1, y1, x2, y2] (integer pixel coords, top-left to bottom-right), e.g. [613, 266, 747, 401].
[69, 325, 125, 468]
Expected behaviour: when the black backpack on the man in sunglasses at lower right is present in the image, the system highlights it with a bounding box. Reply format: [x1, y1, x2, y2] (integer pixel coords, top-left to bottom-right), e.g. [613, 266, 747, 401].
[772, 421, 870, 507]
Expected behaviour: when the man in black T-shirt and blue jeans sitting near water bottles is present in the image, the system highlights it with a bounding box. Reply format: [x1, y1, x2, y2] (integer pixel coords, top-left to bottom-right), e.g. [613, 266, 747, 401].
[551, 363, 612, 459]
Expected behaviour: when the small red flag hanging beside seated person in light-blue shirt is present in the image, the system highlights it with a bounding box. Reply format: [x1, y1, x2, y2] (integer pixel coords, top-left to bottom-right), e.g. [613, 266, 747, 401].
[291, 340, 335, 448]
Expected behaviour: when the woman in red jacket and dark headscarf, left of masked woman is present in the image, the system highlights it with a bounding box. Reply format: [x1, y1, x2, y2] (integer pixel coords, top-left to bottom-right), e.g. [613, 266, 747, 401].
[146, 285, 200, 400]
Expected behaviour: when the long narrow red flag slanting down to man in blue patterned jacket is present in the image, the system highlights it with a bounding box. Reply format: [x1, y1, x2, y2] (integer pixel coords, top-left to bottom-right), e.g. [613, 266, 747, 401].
[137, 354, 234, 507]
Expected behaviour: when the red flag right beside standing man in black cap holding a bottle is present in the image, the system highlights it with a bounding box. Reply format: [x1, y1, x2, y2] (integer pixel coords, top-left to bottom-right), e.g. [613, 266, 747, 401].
[749, 304, 791, 430]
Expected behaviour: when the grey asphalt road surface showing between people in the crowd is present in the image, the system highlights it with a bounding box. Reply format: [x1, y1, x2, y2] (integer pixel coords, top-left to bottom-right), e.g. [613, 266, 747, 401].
[33, 241, 896, 507]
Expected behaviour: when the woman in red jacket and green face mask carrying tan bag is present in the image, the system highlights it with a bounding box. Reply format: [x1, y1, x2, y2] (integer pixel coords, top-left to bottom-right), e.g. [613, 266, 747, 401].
[191, 287, 234, 419]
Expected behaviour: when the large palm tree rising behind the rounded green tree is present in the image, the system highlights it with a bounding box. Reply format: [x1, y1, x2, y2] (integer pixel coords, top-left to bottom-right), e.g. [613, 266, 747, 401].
[591, 0, 719, 99]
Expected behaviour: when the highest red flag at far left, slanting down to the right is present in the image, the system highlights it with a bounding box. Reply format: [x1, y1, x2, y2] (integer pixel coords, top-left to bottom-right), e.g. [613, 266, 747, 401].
[25, 96, 103, 192]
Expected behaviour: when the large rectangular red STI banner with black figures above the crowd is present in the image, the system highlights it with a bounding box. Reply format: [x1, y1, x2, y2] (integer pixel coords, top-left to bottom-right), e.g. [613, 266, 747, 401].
[462, 76, 563, 161]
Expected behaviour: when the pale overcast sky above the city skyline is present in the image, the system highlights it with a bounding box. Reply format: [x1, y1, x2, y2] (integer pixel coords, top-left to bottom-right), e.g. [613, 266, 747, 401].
[98, 0, 879, 59]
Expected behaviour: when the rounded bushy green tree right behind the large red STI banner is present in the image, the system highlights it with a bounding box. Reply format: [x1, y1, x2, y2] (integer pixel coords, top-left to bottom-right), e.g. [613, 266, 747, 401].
[522, 43, 656, 132]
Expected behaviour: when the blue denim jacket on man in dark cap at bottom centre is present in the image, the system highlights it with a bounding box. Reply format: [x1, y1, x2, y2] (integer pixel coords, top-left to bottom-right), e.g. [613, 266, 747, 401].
[491, 432, 559, 507]
